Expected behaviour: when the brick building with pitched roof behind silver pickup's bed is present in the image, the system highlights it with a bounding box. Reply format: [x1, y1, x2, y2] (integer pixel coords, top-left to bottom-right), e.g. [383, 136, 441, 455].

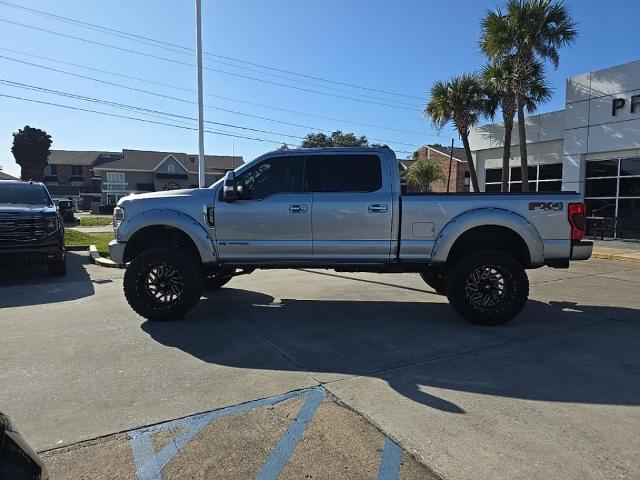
[400, 145, 469, 193]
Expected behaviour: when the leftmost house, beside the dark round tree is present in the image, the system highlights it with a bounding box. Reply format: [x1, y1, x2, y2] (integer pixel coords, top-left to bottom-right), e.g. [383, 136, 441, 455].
[44, 150, 121, 210]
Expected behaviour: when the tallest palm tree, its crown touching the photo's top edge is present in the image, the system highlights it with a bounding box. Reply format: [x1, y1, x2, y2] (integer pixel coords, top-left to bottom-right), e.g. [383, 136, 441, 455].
[480, 0, 578, 192]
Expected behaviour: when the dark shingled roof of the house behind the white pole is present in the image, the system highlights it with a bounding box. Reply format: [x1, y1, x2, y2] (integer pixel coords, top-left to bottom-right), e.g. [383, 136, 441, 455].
[94, 150, 244, 173]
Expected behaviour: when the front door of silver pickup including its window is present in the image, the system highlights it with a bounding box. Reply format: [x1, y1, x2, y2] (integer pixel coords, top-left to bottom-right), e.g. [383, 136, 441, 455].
[214, 155, 312, 263]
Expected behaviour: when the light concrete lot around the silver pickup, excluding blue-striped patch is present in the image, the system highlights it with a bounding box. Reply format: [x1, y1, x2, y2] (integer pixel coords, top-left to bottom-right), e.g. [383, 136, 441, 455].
[0, 254, 640, 479]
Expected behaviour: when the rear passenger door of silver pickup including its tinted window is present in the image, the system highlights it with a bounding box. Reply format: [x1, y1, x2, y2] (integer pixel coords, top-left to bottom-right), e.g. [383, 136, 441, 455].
[307, 152, 393, 263]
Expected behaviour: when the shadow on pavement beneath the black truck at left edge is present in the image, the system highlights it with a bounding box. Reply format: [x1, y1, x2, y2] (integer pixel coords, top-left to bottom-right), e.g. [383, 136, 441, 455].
[0, 253, 100, 308]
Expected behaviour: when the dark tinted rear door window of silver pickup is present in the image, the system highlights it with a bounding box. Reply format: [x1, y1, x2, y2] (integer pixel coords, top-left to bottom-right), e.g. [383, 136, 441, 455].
[306, 155, 382, 192]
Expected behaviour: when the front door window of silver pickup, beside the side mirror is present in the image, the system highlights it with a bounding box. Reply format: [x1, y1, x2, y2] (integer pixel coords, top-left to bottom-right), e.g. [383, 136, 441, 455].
[237, 156, 304, 200]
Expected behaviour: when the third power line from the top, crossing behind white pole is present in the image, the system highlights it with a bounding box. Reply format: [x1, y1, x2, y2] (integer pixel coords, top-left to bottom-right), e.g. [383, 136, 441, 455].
[0, 47, 436, 138]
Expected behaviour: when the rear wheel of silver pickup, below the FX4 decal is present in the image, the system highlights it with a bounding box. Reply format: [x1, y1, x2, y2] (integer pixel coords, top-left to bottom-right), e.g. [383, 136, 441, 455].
[447, 250, 529, 325]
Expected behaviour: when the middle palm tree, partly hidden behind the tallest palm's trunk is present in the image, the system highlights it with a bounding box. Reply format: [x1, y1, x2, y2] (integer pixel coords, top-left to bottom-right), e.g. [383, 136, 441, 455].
[481, 57, 551, 192]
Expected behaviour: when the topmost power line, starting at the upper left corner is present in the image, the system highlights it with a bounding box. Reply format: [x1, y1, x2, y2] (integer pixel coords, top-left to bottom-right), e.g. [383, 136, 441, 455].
[0, 1, 424, 101]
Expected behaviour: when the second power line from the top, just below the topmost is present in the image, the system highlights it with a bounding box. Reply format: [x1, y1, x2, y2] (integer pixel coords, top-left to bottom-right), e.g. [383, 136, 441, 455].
[0, 18, 421, 111]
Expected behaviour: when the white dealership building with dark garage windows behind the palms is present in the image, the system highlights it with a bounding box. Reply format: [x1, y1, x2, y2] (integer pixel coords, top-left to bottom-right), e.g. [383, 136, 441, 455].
[470, 61, 640, 236]
